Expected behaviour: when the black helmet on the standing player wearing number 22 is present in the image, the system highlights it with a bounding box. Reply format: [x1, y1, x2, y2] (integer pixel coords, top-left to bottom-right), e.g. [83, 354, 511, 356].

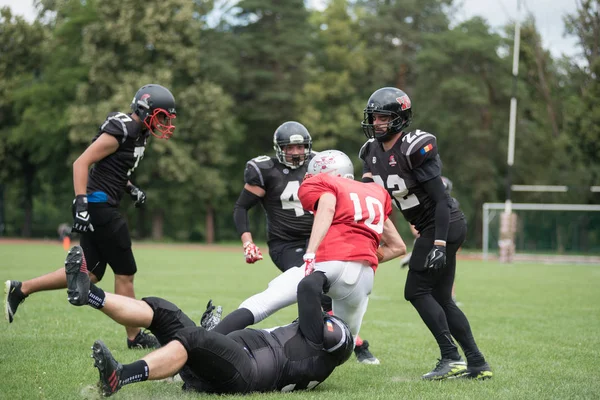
[361, 87, 412, 142]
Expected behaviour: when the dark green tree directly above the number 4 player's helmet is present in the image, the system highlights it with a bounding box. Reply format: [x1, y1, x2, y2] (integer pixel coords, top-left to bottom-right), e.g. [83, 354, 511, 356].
[230, 0, 313, 159]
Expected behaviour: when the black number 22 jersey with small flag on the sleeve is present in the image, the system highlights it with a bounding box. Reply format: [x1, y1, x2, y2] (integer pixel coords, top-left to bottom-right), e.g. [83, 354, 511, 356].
[359, 130, 463, 231]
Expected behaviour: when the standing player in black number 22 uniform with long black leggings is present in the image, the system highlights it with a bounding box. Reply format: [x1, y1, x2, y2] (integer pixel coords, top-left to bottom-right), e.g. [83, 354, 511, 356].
[359, 87, 492, 379]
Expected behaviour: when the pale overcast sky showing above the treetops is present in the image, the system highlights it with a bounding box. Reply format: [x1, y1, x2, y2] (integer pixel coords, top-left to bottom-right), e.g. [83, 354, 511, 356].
[0, 0, 581, 57]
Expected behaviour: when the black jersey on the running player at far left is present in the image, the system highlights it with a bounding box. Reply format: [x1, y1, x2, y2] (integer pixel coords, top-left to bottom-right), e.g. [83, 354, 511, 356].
[87, 112, 150, 206]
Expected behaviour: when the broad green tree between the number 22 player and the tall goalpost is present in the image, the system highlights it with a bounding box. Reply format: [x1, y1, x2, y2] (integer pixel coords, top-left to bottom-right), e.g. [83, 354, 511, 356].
[409, 18, 511, 247]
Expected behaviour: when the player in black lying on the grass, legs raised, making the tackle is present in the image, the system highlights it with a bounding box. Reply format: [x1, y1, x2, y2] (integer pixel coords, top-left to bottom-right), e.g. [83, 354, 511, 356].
[65, 246, 354, 396]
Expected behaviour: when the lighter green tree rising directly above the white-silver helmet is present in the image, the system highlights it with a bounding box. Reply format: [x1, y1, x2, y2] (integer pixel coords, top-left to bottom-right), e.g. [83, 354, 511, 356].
[297, 0, 369, 158]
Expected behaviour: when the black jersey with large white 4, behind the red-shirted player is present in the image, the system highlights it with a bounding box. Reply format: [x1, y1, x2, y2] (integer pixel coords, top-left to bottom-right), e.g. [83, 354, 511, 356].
[244, 156, 314, 242]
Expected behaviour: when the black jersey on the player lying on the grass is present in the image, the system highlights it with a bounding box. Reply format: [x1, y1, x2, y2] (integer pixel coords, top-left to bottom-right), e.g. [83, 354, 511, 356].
[227, 320, 338, 392]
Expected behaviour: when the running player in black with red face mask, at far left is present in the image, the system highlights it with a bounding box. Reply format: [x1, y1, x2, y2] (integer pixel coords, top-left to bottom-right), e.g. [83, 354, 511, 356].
[4, 84, 176, 348]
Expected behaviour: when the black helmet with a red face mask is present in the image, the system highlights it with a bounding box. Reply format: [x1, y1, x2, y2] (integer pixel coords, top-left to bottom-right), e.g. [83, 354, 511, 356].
[131, 84, 177, 139]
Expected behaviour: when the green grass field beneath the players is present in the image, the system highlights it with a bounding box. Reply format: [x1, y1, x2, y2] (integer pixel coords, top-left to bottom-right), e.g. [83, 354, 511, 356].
[0, 243, 600, 400]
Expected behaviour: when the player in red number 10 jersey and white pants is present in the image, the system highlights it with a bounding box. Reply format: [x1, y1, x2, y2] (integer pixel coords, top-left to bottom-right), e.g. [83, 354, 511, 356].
[298, 150, 406, 335]
